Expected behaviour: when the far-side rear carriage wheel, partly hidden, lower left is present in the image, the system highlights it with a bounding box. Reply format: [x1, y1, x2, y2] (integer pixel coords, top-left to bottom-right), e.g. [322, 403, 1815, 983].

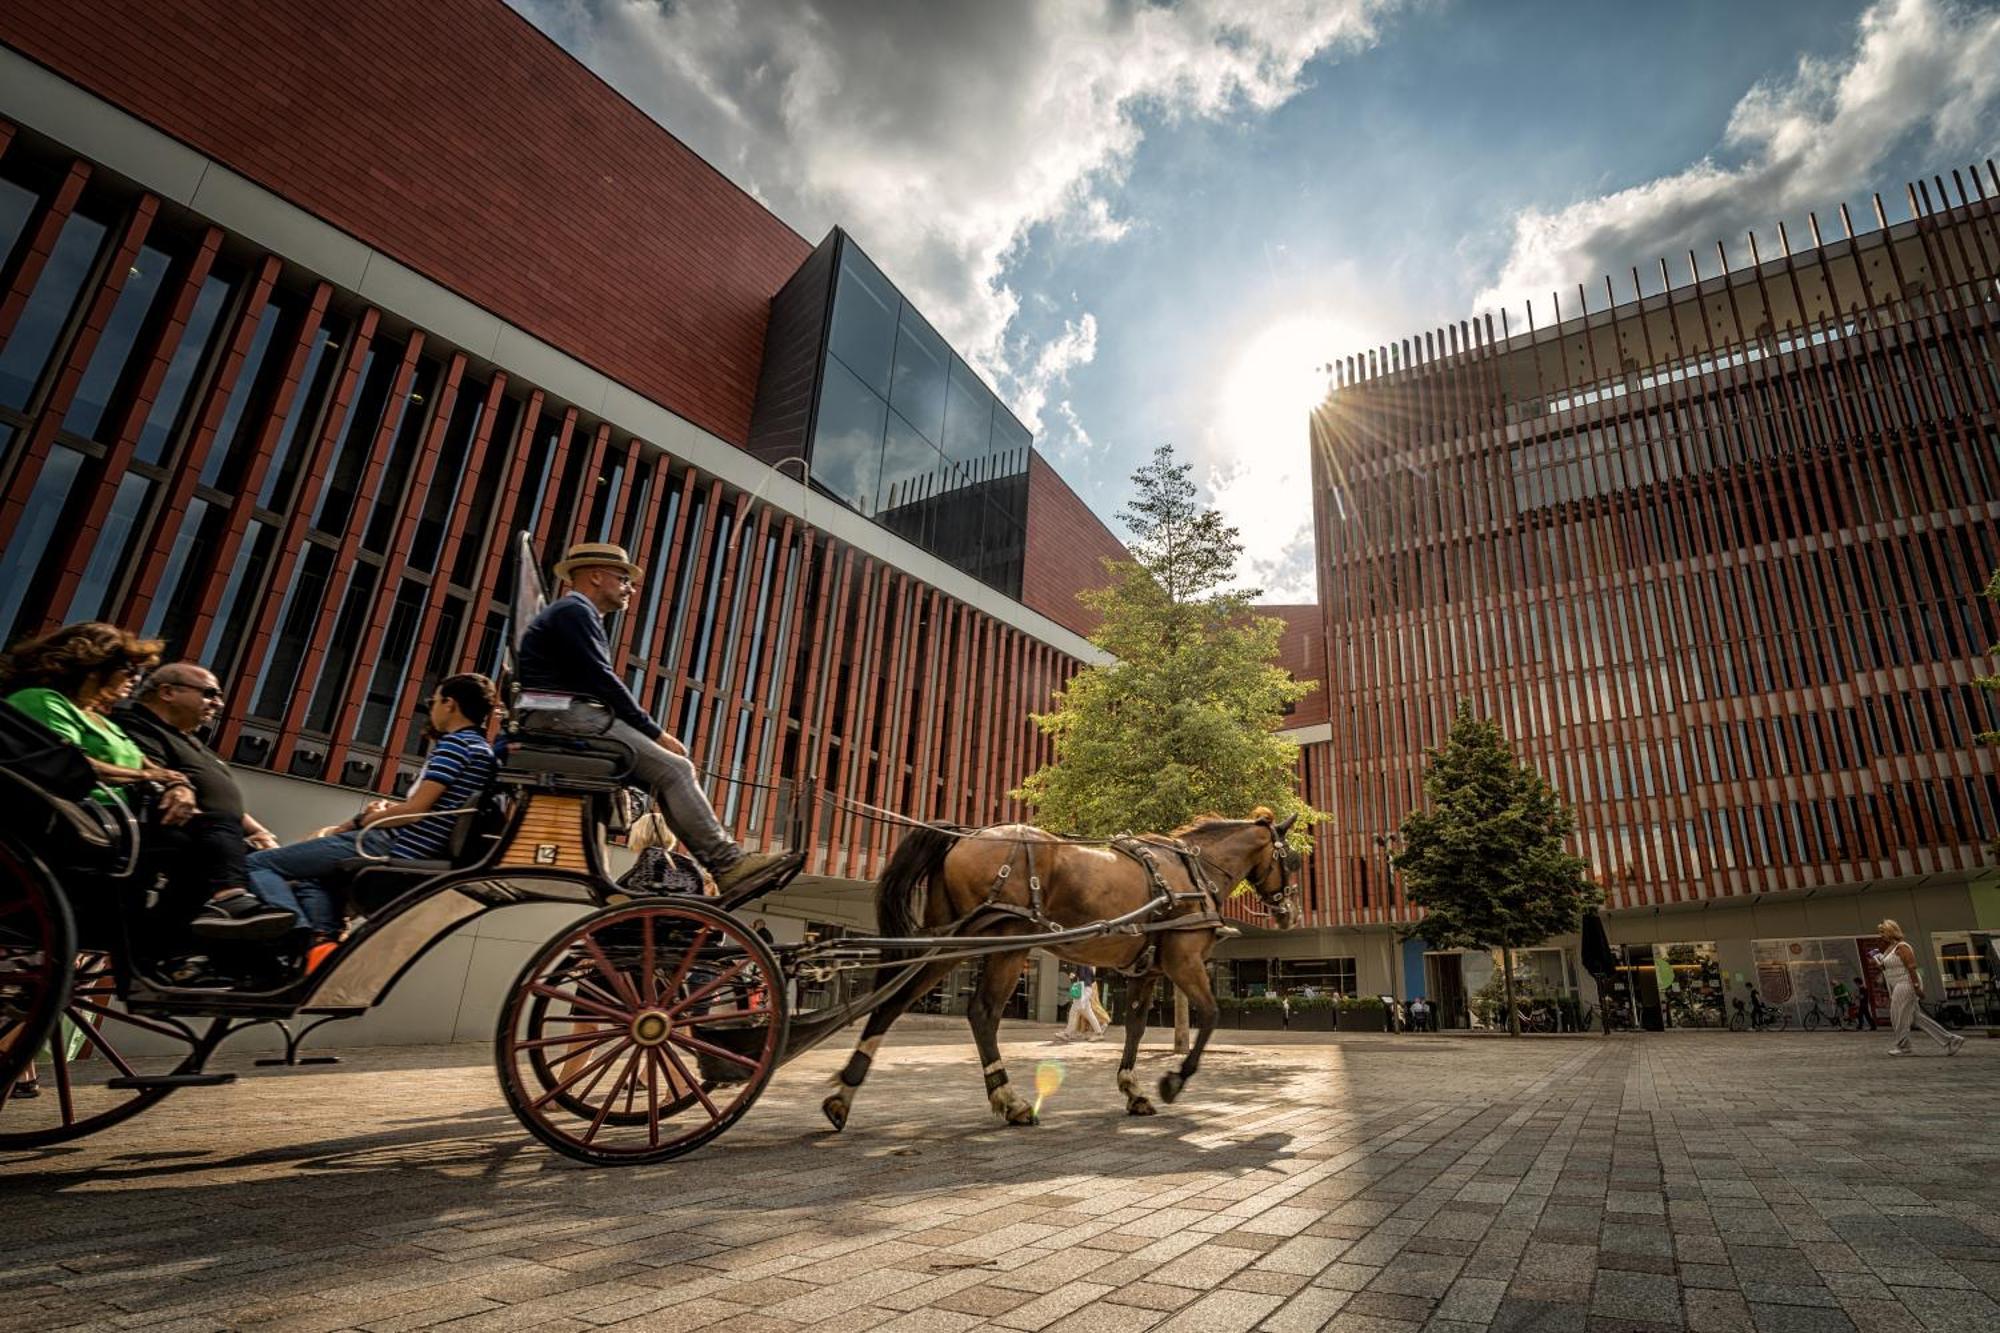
[0, 953, 220, 1153]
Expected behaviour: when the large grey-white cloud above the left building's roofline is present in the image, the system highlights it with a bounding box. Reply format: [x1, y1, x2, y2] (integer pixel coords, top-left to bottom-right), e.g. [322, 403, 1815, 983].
[512, 0, 1394, 420]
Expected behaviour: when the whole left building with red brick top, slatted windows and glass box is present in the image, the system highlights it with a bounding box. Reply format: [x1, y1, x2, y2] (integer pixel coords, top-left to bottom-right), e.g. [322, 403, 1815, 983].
[0, 0, 1118, 1035]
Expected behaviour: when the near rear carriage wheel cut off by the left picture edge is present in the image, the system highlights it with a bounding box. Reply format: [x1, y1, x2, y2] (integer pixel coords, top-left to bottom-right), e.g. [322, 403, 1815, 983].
[0, 841, 76, 1123]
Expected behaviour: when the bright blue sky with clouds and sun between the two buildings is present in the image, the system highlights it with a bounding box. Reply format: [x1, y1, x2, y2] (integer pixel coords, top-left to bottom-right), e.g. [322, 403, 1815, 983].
[510, 0, 2000, 602]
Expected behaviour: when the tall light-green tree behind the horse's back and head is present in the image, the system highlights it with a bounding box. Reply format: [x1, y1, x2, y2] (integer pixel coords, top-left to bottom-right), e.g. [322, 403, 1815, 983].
[1012, 444, 1324, 1029]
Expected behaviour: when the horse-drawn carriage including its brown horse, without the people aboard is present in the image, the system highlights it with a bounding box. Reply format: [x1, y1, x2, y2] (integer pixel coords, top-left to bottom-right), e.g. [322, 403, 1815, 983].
[0, 536, 1298, 1165]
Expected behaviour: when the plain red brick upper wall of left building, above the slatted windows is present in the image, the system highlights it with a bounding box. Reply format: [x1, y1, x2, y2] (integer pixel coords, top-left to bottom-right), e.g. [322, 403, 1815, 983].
[0, 0, 812, 444]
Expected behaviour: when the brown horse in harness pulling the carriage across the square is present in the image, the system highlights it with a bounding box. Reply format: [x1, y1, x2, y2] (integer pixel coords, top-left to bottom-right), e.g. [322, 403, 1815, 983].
[820, 807, 1298, 1129]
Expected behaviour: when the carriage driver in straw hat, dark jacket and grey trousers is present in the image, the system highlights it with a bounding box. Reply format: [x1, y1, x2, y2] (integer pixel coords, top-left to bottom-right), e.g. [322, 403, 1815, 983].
[518, 542, 786, 893]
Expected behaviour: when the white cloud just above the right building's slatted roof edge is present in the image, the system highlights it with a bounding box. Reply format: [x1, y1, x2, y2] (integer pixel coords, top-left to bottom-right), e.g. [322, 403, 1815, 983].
[1474, 0, 2000, 310]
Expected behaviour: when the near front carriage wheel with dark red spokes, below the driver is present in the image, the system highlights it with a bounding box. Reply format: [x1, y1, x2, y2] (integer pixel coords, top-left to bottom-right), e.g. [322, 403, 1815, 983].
[494, 899, 790, 1165]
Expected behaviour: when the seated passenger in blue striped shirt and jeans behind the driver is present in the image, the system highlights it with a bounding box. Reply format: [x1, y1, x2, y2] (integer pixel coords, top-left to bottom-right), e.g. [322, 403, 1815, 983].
[250, 673, 500, 945]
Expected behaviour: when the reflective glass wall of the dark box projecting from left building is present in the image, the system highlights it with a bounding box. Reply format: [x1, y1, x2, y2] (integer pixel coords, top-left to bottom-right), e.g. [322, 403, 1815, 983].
[808, 232, 1032, 596]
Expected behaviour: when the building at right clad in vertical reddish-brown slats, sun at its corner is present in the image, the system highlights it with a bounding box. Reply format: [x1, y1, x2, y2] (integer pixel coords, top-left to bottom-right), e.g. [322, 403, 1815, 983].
[1230, 176, 2000, 1025]
